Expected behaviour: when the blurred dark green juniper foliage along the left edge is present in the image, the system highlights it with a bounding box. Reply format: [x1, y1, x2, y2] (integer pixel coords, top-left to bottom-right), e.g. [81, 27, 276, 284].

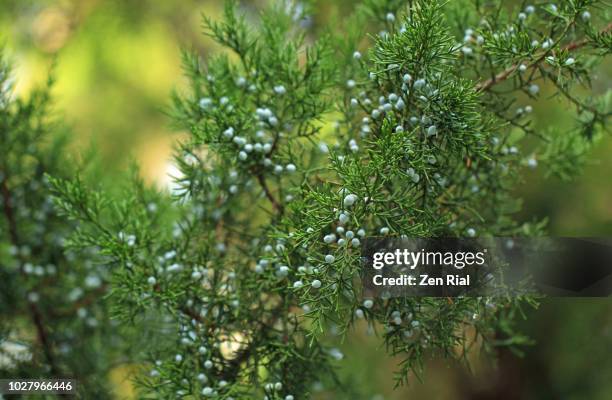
[0, 54, 128, 399]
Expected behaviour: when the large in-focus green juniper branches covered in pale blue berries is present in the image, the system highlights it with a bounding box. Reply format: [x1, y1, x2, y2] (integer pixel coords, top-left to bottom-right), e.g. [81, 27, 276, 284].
[37, 0, 611, 400]
